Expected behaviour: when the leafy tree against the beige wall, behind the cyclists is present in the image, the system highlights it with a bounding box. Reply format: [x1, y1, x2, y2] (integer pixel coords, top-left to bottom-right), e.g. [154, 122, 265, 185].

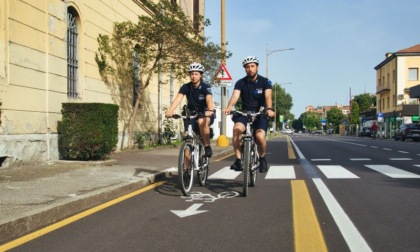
[96, 0, 231, 147]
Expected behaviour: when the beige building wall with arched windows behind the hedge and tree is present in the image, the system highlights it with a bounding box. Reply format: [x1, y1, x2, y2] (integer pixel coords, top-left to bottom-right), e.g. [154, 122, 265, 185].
[0, 0, 204, 167]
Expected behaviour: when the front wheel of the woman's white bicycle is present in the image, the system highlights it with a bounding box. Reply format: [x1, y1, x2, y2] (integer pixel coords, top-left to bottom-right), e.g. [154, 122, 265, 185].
[178, 143, 194, 196]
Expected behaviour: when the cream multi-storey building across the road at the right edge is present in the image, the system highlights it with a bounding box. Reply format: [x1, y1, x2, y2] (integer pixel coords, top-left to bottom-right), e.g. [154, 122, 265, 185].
[375, 44, 420, 137]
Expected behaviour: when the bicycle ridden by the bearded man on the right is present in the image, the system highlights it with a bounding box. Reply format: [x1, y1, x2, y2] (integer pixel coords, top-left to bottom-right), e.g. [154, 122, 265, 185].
[230, 111, 265, 197]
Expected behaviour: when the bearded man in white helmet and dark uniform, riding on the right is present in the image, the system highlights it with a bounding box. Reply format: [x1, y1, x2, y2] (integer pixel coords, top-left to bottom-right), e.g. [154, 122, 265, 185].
[224, 56, 275, 173]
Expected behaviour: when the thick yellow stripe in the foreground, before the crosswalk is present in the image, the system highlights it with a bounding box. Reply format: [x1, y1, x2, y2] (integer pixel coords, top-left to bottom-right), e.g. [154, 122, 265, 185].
[291, 180, 328, 252]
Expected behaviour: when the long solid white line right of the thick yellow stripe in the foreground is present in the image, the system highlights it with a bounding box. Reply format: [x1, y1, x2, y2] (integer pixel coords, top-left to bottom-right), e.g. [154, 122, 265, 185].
[313, 178, 372, 251]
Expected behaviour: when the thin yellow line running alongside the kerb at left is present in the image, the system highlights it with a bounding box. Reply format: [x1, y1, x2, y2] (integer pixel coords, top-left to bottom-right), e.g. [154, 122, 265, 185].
[0, 181, 165, 251]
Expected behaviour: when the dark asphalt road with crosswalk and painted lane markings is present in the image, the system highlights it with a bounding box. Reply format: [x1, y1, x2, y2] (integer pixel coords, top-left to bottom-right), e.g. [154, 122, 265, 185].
[7, 135, 420, 251]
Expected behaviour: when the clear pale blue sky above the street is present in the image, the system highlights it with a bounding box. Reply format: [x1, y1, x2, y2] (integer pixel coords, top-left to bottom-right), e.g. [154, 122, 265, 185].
[205, 0, 420, 119]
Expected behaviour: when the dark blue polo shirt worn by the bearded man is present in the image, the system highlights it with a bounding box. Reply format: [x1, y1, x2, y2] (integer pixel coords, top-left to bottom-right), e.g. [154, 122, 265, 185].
[234, 75, 272, 111]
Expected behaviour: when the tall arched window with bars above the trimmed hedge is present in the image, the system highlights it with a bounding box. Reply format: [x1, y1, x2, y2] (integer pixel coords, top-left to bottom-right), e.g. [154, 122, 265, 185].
[67, 8, 79, 98]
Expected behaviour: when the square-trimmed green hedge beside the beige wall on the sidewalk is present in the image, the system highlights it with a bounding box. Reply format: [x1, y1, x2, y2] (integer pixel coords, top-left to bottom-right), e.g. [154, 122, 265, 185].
[59, 103, 118, 160]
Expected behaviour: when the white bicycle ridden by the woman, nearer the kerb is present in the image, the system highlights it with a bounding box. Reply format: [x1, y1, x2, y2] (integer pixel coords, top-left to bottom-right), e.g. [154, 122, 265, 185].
[172, 110, 210, 196]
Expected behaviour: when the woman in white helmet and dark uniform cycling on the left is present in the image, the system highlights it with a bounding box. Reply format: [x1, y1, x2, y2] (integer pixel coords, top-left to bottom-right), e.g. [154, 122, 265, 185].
[165, 62, 214, 157]
